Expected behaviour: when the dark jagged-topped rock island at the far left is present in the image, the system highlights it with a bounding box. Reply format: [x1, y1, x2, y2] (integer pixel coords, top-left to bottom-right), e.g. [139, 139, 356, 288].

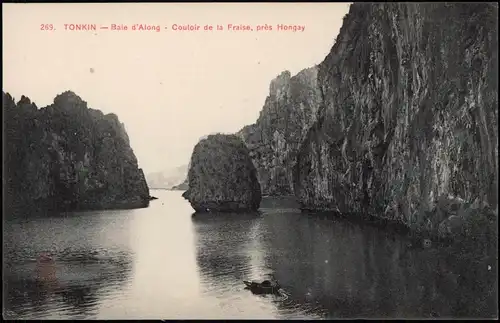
[3, 91, 149, 210]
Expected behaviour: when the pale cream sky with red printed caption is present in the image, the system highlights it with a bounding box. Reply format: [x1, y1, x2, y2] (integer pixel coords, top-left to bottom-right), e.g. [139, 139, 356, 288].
[2, 3, 349, 173]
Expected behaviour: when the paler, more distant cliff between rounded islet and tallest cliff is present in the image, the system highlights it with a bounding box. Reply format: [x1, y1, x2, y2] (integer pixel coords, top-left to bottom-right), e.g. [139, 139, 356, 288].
[237, 67, 320, 195]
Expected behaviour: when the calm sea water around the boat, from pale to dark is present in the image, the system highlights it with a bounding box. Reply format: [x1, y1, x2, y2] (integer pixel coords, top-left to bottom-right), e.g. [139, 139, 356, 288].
[4, 191, 497, 319]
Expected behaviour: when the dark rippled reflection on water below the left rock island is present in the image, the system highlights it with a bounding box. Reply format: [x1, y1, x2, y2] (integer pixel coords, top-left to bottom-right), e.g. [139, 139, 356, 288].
[4, 212, 132, 319]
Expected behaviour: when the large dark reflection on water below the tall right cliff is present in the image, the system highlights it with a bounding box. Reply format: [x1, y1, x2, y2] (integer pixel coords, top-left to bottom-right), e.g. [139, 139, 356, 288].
[262, 213, 497, 318]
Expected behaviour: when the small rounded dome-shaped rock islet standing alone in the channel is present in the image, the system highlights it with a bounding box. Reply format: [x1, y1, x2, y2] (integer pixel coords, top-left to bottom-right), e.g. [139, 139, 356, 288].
[182, 134, 261, 213]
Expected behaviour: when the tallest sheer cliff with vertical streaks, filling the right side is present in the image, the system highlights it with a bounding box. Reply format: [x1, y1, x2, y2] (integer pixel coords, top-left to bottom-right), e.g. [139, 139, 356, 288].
[295, 3, 498, 238]
